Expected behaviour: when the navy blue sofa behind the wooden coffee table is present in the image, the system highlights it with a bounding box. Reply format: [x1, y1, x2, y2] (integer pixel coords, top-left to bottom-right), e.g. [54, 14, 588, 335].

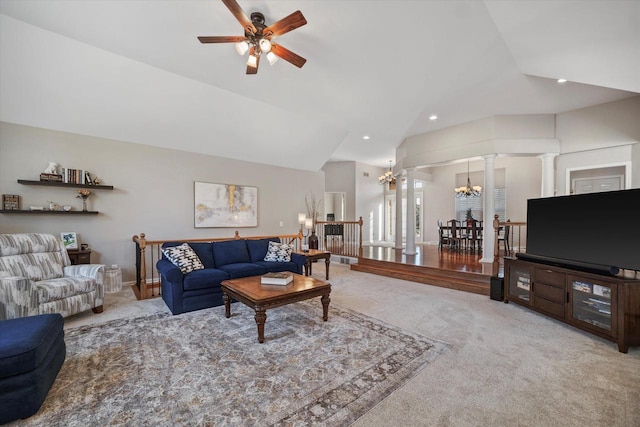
[156, 237, 306, 314]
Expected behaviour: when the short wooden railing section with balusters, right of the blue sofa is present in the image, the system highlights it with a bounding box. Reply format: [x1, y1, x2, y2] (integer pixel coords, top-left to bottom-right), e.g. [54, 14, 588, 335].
[315, 217, 364, 258]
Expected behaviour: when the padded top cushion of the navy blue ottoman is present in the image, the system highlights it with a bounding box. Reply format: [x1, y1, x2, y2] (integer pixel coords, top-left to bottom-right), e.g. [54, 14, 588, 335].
[0, 314, 64, 378]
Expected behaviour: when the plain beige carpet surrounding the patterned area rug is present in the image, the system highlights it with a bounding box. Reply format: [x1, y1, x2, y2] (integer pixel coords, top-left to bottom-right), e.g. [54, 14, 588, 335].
[61, 263, 640, 427]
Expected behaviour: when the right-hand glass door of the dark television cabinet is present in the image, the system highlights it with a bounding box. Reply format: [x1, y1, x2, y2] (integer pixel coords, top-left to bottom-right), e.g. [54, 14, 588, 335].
[569, 277, 616, 336]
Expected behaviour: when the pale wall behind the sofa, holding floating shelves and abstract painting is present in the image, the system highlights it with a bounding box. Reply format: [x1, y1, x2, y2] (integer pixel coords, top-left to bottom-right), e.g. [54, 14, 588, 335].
[0, 122, 324, 280]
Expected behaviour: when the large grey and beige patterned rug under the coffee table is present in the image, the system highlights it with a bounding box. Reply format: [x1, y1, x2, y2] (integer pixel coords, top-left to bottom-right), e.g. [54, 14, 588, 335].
[15, 299, 449, 426]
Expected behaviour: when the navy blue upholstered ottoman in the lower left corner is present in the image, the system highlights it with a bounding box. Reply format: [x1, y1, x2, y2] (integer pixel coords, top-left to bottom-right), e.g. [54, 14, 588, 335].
[0, 314, 67, 424]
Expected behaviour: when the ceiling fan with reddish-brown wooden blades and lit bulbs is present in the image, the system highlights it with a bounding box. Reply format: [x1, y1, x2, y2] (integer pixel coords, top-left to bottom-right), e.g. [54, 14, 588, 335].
[198, 0, 307, 74]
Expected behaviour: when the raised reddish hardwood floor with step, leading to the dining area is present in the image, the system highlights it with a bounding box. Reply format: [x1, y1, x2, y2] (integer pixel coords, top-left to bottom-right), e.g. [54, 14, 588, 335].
[351, 244, 502, 295]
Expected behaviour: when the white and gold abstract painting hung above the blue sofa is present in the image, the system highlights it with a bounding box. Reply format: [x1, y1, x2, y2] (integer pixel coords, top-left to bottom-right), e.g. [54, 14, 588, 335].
[193, 181, 258, 228]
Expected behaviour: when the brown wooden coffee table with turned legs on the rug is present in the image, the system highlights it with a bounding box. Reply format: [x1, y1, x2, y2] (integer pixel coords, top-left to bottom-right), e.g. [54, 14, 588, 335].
[221, 274, 331, 343]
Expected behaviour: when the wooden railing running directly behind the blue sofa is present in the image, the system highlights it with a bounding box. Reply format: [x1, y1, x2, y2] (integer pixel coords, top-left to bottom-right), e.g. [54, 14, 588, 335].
[132, 230, 302, 300]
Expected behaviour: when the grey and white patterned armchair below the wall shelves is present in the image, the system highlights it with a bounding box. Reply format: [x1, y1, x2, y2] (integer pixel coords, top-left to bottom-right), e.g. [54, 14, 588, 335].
[0, 233, 105, 319]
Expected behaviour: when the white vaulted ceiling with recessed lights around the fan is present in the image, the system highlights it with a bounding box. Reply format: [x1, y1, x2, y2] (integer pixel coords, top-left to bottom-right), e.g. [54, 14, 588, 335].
[0, 0, 640, 171]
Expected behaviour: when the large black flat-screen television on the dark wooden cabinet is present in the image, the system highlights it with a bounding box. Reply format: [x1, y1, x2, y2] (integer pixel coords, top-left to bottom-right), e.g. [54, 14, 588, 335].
[519, 189, 640, 274]
